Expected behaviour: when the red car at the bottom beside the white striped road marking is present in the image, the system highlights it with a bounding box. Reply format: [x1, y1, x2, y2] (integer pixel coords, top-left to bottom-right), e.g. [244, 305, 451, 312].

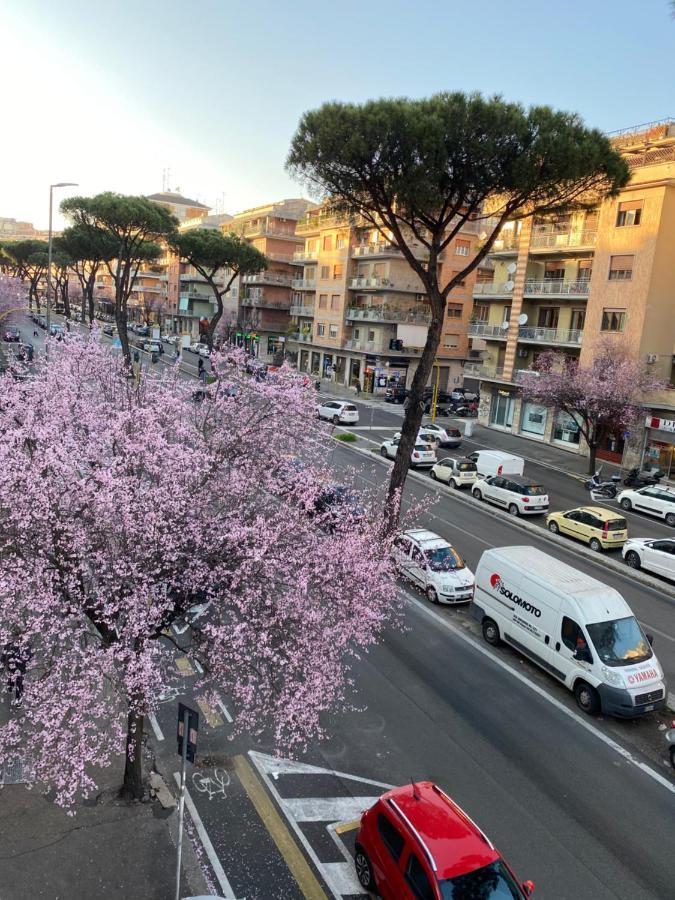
[354, 781, 534, 900]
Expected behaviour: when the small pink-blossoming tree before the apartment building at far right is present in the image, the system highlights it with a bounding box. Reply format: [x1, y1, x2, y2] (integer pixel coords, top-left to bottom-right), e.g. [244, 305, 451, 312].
[519, 338, 664, 475]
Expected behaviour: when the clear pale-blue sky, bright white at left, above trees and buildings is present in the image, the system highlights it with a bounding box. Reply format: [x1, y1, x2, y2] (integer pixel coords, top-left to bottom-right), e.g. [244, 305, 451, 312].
[0, 0, 675, 227]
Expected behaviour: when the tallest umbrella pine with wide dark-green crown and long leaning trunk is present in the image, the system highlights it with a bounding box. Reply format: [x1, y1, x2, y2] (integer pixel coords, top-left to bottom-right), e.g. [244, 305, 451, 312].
[287, 93, 628, 527]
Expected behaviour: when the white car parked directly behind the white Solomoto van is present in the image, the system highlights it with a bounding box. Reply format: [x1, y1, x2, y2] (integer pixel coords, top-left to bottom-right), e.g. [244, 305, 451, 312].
[391, 528, 474, 603]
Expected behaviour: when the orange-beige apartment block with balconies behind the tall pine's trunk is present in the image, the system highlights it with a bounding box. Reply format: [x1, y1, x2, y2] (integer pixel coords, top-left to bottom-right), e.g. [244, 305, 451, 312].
[287, 209, 478, 393]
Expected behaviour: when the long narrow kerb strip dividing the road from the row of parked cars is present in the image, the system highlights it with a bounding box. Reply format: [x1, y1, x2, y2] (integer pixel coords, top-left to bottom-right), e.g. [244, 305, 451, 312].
[339, 441, 675, 604]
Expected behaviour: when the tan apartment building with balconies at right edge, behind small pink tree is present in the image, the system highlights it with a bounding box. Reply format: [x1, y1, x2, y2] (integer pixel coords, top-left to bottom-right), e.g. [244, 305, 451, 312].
[465, 120, 675, 475]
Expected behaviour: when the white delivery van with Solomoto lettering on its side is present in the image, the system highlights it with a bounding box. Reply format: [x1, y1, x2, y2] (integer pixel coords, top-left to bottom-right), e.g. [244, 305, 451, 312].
[471, 547, 667, 718]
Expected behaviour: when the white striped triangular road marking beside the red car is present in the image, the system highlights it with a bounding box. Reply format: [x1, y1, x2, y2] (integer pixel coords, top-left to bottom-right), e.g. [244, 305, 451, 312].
[248, 750, 392, 900]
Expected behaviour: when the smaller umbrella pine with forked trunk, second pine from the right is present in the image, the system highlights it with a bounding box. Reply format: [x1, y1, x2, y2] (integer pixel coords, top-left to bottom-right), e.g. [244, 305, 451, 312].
[171, 228, 267, 349]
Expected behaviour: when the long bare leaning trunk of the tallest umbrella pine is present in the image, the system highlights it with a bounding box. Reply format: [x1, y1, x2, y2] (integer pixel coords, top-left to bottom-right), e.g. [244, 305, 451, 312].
[384, 290, 445, 533]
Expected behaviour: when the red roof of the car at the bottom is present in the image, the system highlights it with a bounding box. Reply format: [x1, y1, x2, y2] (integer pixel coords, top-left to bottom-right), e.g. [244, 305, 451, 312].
[380, 781, 500, 880]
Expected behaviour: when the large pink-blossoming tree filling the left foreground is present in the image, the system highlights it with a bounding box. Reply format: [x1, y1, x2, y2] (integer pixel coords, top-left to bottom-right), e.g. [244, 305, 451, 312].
[0, 335, 397, 804]
